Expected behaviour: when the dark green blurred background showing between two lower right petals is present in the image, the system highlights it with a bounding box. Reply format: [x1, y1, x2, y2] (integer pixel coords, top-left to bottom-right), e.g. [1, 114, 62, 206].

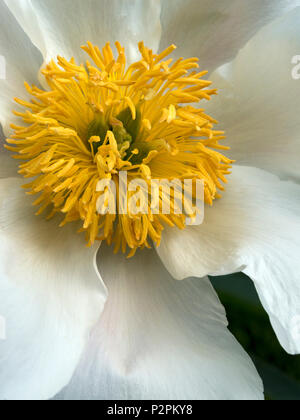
[211, 273, 300, 401]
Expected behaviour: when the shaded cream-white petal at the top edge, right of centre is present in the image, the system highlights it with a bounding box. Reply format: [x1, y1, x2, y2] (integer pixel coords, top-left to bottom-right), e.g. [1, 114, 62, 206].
[160, 0, 300, 70]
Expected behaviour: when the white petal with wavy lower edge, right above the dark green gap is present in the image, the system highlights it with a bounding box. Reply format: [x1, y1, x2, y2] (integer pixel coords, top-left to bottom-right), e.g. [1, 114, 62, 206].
[158, 166, 300, 353]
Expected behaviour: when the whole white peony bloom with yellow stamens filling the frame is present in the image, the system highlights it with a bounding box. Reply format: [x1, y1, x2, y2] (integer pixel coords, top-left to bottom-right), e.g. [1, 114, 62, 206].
[0, 0, 300, 400]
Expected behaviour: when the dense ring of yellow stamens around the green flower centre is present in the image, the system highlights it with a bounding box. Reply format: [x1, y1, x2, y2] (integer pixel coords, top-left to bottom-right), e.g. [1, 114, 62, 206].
[6, 42, 232, 255]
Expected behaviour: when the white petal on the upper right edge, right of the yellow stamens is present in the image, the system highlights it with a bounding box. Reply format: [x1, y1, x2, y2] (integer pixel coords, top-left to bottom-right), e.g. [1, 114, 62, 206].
[207, 8, 300, 180]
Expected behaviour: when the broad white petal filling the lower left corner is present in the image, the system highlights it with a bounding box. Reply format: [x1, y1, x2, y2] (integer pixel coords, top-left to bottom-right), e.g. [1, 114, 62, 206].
[0, 178, 106, 400]
